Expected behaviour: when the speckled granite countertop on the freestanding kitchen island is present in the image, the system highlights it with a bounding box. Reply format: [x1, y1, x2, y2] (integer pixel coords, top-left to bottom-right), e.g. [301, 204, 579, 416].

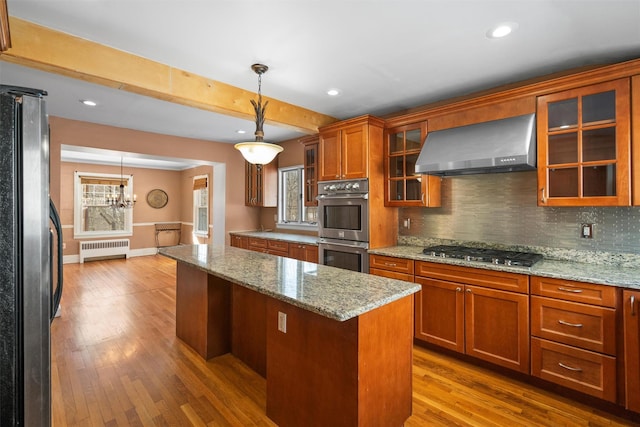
[159, 245, 420, 321]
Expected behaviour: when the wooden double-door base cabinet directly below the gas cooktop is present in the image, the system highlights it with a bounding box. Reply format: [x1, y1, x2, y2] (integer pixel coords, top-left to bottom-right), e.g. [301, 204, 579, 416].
[414, 261, 529, 374]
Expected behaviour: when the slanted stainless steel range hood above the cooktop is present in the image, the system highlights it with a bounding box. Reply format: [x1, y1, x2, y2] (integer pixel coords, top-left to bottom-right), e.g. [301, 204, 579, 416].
[415, 114, 536, 176]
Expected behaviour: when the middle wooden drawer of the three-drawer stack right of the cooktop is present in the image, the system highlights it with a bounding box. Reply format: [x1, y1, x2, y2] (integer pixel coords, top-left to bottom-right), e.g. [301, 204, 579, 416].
[531, 296, 616, 356]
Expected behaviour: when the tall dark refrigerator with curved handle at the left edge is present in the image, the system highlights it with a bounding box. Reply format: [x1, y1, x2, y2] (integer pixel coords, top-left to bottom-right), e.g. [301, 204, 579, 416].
[0, 85, 62, 427]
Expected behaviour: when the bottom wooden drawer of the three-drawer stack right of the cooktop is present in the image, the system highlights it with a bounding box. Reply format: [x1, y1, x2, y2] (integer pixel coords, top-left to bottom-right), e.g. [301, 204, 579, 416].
[531, 338, 616, 402]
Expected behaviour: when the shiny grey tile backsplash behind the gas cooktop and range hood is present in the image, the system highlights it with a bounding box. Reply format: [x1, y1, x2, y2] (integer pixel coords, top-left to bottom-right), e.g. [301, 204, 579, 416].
[398, 172, 640, 254]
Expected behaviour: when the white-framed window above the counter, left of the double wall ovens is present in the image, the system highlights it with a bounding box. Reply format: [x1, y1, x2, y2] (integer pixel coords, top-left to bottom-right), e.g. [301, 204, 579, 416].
[278, 166, 318, 228]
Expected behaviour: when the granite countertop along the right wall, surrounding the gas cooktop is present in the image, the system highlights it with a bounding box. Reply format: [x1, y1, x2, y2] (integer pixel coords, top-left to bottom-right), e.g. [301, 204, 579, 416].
[369, 245, 640, 289]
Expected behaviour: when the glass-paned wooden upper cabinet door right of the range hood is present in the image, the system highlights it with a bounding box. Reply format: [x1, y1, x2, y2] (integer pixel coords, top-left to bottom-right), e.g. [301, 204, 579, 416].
[538, 78, 631, 206]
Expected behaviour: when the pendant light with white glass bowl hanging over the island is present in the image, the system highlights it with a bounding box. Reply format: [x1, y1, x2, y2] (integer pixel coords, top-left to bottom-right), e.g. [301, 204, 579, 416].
[234, 64, 283, 165]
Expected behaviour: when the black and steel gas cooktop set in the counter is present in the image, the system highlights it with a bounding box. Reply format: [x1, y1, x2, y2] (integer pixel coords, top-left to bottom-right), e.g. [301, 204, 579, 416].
[422, 245, 542, 267]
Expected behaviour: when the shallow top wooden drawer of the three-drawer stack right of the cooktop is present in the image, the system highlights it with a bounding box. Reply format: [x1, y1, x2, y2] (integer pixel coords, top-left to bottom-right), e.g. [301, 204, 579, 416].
[531, 276, 617, 308]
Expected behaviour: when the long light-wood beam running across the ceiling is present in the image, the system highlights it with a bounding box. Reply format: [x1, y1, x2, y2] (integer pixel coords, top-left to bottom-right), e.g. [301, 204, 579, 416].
[0, 16, 337, 134]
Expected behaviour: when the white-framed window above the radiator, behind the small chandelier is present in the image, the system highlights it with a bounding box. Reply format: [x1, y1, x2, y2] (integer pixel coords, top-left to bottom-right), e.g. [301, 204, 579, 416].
[73, 172, 133, 238]
